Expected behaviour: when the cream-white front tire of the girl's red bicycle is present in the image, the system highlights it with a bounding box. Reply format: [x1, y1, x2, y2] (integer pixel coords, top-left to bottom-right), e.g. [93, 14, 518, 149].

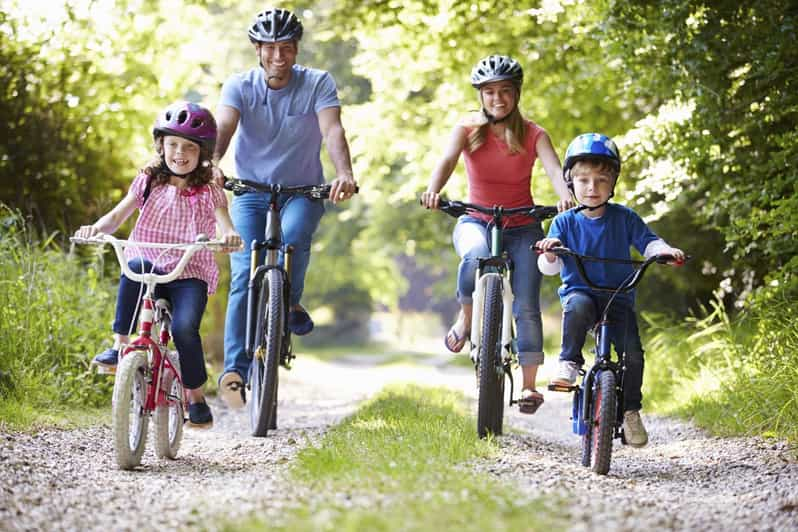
[111, 351, 150, 469]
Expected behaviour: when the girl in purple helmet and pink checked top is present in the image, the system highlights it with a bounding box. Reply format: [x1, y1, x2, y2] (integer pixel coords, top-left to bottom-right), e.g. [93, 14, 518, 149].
[75, 102, 241, 428]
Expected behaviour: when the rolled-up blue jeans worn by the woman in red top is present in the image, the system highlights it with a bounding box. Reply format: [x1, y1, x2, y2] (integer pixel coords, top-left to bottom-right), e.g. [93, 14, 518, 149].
[452, 216, 543, 366]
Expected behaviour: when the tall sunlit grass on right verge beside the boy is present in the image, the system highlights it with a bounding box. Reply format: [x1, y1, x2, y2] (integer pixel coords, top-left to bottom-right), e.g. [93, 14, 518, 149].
[644, 278, 798, 442]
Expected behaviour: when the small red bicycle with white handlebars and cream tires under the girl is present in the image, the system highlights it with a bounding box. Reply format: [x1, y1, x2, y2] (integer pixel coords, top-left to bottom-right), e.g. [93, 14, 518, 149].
[70, 234, 228, 469]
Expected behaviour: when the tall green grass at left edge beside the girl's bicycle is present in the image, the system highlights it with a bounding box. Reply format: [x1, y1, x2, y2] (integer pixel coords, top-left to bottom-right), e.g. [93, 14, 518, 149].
[0, 207, 115, 424]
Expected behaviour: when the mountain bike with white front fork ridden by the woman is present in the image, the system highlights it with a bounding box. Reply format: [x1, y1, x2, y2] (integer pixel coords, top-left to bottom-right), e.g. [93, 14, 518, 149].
[432, 199, 557, 438]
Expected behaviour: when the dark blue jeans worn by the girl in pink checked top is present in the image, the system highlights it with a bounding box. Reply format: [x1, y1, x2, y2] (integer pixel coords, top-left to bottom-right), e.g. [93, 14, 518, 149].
[114, 259, 208, 389]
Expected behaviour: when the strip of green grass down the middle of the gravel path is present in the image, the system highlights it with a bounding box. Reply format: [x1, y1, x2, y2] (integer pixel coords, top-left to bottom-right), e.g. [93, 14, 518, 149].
[224, 385, 563, 531]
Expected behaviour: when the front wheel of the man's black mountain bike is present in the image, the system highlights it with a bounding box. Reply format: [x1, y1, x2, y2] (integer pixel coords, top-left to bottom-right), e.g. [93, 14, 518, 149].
[249, 268, 285, 437]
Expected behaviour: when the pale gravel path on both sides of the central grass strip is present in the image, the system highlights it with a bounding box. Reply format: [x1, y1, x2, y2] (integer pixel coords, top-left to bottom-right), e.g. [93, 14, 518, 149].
[0, 357, 798, 532]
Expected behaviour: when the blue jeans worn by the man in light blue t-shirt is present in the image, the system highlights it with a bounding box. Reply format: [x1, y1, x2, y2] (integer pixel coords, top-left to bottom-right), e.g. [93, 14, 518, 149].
[224, 192, 324, 382]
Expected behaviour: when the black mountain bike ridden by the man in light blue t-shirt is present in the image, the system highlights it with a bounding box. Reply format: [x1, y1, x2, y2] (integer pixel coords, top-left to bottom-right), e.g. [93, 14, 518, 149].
[224, 179, 357, 436]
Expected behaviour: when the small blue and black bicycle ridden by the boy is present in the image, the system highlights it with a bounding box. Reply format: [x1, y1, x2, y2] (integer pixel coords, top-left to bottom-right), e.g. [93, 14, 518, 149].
[536, 247, 690, 475]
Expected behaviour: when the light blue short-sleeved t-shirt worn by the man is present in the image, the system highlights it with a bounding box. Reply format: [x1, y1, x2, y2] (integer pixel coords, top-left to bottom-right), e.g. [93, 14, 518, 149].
[219, 65, 341, 185]
